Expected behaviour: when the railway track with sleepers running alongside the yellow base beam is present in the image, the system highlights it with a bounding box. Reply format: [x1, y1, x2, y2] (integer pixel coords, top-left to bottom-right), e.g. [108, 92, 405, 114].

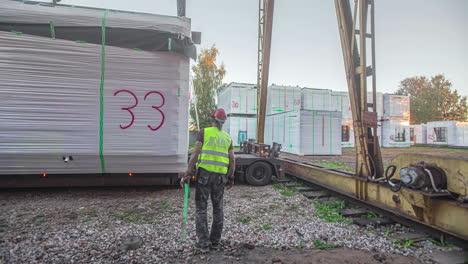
[277, 159, 468, 249]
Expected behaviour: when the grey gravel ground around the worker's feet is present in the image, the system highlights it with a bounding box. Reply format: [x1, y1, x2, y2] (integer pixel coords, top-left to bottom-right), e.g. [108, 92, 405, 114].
[0, 185, 461, 264]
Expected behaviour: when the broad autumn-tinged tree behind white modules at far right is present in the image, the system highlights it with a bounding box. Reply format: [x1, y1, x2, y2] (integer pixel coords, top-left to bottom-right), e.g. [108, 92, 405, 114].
[396, 74, 468, 124]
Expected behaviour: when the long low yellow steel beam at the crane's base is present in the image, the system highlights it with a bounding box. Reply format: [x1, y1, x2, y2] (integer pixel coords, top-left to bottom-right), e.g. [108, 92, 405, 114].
[284, 159, 468, 240]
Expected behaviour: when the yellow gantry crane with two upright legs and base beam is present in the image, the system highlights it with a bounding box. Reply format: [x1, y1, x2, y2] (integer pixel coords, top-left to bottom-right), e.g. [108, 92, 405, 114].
[257, 0, 468, 242]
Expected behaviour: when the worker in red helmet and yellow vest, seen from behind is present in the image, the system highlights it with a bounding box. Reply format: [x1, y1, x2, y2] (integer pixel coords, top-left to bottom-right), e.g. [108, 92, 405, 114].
[180, 109, 235, 252]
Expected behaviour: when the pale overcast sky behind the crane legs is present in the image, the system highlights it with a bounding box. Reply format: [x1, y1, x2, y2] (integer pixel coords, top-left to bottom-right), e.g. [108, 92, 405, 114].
[41, 0, 468, 95]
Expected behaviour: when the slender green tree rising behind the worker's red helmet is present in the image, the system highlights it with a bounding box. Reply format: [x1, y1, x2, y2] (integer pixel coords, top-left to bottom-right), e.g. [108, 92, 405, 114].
[190, 45, 226, 129]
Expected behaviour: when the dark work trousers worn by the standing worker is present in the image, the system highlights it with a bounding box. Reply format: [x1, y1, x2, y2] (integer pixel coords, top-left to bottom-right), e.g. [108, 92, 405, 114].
[195, 168, 227, 247]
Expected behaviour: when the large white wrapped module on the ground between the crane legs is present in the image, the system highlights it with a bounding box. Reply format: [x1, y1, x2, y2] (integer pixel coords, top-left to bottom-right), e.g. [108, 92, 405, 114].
[266, 110, 341, 155]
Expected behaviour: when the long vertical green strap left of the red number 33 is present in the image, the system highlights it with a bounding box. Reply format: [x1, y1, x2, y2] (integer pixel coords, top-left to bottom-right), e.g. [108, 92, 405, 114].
[99, 10, 107, 173]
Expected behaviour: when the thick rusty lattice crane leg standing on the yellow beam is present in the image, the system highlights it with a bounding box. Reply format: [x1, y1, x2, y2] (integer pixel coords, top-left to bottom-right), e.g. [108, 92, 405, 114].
[335, 0, 383, 179]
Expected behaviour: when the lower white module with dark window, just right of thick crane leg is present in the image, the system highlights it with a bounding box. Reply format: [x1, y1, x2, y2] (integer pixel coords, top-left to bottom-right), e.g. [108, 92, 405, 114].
[381, 120, 411, 148]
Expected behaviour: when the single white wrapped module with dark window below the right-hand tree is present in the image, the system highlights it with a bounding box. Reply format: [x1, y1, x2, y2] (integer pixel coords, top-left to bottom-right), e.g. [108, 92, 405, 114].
[427, 121, 457, 146]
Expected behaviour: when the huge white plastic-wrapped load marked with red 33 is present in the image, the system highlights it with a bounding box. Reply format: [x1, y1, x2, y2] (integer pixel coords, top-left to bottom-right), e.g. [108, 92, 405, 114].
[0, 1, 194, 174]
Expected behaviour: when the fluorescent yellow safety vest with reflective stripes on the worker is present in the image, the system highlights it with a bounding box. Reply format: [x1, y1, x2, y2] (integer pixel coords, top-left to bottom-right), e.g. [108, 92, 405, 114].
[197, 127, 231, 174]
